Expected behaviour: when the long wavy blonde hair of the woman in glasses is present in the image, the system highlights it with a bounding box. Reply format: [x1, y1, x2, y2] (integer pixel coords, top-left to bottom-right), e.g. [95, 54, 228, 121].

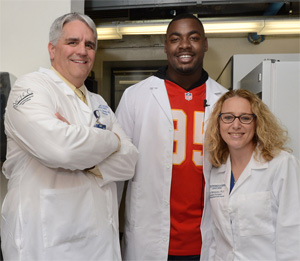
[204, 89, 291, 167]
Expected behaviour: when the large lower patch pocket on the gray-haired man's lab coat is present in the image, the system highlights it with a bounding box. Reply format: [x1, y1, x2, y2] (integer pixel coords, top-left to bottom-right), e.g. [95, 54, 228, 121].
[40, 186, 97, 247]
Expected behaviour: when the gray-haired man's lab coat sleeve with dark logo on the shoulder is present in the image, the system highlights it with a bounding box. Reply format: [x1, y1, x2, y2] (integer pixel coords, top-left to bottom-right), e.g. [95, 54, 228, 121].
[5, 74, 118, 170]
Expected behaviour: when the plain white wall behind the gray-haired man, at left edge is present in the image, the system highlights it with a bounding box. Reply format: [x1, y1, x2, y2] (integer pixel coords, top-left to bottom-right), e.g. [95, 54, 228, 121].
[0, 0, 84, 225]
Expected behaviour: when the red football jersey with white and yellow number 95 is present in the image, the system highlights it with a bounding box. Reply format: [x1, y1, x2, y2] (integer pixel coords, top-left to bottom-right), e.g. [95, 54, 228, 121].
[165, 80, 206, 256]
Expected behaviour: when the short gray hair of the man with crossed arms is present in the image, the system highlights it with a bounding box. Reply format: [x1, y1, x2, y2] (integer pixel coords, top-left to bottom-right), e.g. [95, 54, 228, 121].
[49, 13, 97, 50]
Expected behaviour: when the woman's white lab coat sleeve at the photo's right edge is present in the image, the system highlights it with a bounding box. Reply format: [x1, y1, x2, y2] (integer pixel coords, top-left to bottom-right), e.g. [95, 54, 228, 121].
[273, 154, 300, 260]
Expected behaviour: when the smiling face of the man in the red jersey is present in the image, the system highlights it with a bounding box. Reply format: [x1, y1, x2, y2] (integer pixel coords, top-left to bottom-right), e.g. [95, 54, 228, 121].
[165, 18, 208, 75]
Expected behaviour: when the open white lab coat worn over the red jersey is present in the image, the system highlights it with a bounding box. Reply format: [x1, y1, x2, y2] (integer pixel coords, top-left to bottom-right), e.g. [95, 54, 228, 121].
[116, 76, 226, 261]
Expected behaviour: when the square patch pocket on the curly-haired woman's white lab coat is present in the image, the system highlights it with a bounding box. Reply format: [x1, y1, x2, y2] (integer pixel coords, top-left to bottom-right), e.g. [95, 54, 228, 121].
[238, 192, 275, 236]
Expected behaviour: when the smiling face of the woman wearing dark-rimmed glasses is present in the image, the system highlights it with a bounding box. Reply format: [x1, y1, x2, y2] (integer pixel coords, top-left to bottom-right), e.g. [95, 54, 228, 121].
[219, 96, 255, 153]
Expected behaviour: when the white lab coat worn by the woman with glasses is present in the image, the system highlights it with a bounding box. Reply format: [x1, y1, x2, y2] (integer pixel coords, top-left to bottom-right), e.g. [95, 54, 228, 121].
[201, 151, 300, 261]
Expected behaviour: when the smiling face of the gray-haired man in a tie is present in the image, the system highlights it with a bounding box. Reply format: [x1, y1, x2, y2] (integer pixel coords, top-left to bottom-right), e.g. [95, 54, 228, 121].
[48, 20, 96, 88]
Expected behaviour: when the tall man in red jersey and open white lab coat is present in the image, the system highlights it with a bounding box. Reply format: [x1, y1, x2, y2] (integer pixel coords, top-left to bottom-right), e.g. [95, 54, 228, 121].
[116, 14, 226, 260]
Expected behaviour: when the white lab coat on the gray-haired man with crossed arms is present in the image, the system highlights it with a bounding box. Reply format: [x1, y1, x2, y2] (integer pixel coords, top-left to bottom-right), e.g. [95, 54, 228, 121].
[1, 69, 137, 261]
